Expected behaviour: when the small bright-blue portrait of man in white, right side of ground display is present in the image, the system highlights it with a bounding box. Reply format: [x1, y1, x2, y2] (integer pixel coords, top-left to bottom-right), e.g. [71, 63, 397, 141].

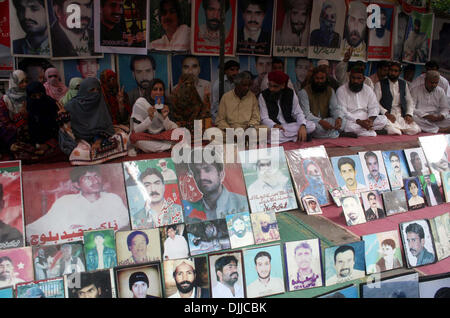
[382, 150, 409, 190]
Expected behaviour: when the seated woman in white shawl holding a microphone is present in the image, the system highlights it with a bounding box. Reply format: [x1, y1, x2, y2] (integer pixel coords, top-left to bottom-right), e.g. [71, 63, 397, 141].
[130, 79, 178, 155]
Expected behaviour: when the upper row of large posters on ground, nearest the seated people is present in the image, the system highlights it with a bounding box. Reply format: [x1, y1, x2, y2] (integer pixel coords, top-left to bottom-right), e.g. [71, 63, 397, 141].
[0, 135, 450, 248]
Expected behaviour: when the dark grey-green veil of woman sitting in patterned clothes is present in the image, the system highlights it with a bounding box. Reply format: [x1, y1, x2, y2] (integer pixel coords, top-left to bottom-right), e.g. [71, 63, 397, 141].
[66, 77, 114, 141]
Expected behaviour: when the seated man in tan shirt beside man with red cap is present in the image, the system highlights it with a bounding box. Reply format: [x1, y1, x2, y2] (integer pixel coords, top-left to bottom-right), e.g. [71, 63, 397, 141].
[216, 72, 264, 130]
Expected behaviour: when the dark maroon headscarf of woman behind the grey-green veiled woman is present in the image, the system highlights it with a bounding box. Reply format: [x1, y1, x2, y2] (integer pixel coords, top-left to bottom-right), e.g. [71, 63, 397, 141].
[100, 70, 131, 125]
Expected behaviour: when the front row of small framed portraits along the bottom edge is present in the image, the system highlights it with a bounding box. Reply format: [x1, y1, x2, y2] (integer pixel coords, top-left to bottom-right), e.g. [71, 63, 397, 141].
[0, 213, 450, 298]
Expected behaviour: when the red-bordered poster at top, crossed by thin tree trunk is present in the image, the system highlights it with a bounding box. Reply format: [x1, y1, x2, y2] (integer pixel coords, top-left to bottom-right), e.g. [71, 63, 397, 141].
[191, 0, 237, 56]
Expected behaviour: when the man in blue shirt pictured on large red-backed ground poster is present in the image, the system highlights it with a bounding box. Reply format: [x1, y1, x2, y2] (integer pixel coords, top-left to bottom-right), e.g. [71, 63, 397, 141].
[186, 149, 248, 223]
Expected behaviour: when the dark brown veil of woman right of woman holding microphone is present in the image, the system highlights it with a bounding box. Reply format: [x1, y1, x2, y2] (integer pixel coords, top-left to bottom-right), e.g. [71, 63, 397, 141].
[170, 74, 211, 133]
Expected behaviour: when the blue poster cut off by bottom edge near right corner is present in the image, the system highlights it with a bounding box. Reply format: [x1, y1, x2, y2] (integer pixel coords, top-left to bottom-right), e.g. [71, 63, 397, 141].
[359, 273, 419, 298]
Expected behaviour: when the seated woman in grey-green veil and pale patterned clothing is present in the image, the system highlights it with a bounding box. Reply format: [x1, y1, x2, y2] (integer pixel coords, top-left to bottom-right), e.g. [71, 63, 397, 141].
[65, 77, 128, 165]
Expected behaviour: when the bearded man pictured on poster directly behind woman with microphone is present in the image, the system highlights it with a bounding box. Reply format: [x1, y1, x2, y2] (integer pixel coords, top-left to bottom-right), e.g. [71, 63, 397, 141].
[127, 55, 156, 105]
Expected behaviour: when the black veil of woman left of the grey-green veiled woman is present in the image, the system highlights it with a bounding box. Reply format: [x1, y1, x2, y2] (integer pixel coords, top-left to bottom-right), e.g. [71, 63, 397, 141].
[27, 82, 59, 143]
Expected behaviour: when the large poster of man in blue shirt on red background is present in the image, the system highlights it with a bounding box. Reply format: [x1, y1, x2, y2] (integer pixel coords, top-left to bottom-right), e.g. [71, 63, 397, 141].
[175, 147, 249, 224]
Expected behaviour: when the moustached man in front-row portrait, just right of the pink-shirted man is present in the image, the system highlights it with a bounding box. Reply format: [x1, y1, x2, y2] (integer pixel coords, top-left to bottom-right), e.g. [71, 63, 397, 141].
[326, 245, 365, 286]
